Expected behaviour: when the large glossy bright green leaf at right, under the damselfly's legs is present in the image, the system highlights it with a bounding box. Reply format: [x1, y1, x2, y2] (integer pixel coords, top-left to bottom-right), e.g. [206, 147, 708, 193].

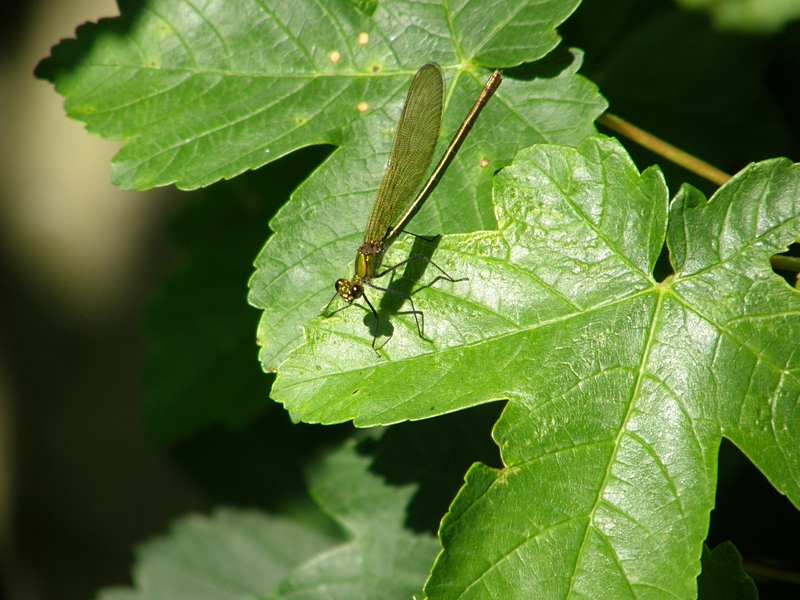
[273, 137, 800, 598]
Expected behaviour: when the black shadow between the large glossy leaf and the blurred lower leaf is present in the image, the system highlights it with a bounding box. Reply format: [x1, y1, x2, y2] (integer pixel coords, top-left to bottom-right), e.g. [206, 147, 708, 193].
[359, 402, 506, 535]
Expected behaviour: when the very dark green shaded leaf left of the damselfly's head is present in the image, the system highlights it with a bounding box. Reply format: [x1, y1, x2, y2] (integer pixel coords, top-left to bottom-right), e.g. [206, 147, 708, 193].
[145, 146, 333, 447]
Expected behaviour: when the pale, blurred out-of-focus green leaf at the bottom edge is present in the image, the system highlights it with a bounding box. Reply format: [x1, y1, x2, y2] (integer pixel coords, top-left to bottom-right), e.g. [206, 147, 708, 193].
[100, 442, 440, 600]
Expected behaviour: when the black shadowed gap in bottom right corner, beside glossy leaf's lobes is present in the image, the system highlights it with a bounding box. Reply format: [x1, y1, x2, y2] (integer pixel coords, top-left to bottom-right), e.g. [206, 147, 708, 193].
[706, 438, 800, 600]
